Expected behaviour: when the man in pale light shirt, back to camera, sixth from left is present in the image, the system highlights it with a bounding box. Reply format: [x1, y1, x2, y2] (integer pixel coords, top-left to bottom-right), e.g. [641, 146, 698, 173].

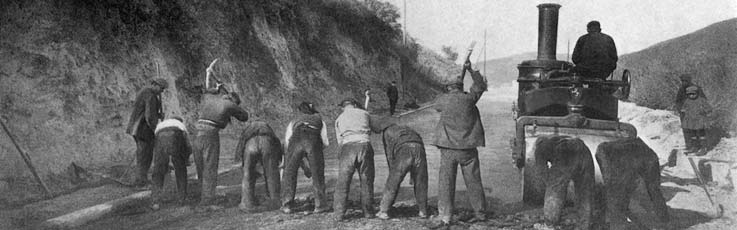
[333, 91, 374, 221]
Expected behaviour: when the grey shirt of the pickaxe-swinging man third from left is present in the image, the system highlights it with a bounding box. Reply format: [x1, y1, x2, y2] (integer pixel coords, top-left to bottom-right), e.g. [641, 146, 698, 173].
[200, 95, 248, 129]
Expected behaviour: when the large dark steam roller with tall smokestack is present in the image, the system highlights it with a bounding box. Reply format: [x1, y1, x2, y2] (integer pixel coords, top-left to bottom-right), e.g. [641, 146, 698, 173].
[511, 4, 637, 205]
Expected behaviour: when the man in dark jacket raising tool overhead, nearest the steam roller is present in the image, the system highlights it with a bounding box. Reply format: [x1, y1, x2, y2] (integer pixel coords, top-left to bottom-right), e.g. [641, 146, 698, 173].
[433, 61, 487, 226]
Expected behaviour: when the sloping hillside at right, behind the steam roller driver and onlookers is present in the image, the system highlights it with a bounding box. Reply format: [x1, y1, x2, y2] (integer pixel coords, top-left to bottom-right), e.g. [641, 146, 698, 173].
[615, 18, 737, 130]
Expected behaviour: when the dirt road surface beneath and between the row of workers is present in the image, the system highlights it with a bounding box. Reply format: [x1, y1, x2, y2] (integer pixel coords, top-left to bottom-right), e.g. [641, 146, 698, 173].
[76, 96, 720, 229]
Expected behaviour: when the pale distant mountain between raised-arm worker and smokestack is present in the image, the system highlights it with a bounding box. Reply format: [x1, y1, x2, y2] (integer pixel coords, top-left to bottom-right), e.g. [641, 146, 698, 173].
[473, 52, 566, 86]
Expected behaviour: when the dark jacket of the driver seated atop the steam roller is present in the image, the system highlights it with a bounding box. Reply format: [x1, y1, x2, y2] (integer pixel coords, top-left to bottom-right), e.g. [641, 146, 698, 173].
[572, 32, 619, 76]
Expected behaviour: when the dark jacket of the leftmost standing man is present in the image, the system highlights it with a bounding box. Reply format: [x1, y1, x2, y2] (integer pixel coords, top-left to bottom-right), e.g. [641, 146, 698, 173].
[125, 87, 164, 140]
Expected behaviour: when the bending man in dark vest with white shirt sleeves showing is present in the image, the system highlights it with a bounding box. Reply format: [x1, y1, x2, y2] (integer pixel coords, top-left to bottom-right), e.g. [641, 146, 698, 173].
[281, 102, 330, 213]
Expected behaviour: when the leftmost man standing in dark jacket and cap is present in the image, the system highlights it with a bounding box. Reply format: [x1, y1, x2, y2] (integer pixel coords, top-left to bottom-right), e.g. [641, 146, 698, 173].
[125, 78, 169, 186]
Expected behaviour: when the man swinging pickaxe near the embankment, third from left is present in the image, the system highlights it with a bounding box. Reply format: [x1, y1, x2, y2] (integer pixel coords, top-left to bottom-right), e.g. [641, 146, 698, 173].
[194, 92, 248, 206]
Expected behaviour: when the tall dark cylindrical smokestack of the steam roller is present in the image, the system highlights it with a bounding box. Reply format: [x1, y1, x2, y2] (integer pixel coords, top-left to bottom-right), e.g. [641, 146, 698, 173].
[537, 3, 560, 60]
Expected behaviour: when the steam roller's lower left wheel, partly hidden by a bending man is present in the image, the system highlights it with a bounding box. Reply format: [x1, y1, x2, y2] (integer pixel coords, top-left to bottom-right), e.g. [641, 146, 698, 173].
[522, 158, 547, 205]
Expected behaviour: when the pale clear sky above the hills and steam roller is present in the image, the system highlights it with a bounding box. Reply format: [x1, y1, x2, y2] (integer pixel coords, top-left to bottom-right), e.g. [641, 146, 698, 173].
[384, 0, 737, 62]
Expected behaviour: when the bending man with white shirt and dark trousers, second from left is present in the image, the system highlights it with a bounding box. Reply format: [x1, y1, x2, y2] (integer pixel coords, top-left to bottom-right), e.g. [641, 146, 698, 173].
[151, 117, 192, 209]
